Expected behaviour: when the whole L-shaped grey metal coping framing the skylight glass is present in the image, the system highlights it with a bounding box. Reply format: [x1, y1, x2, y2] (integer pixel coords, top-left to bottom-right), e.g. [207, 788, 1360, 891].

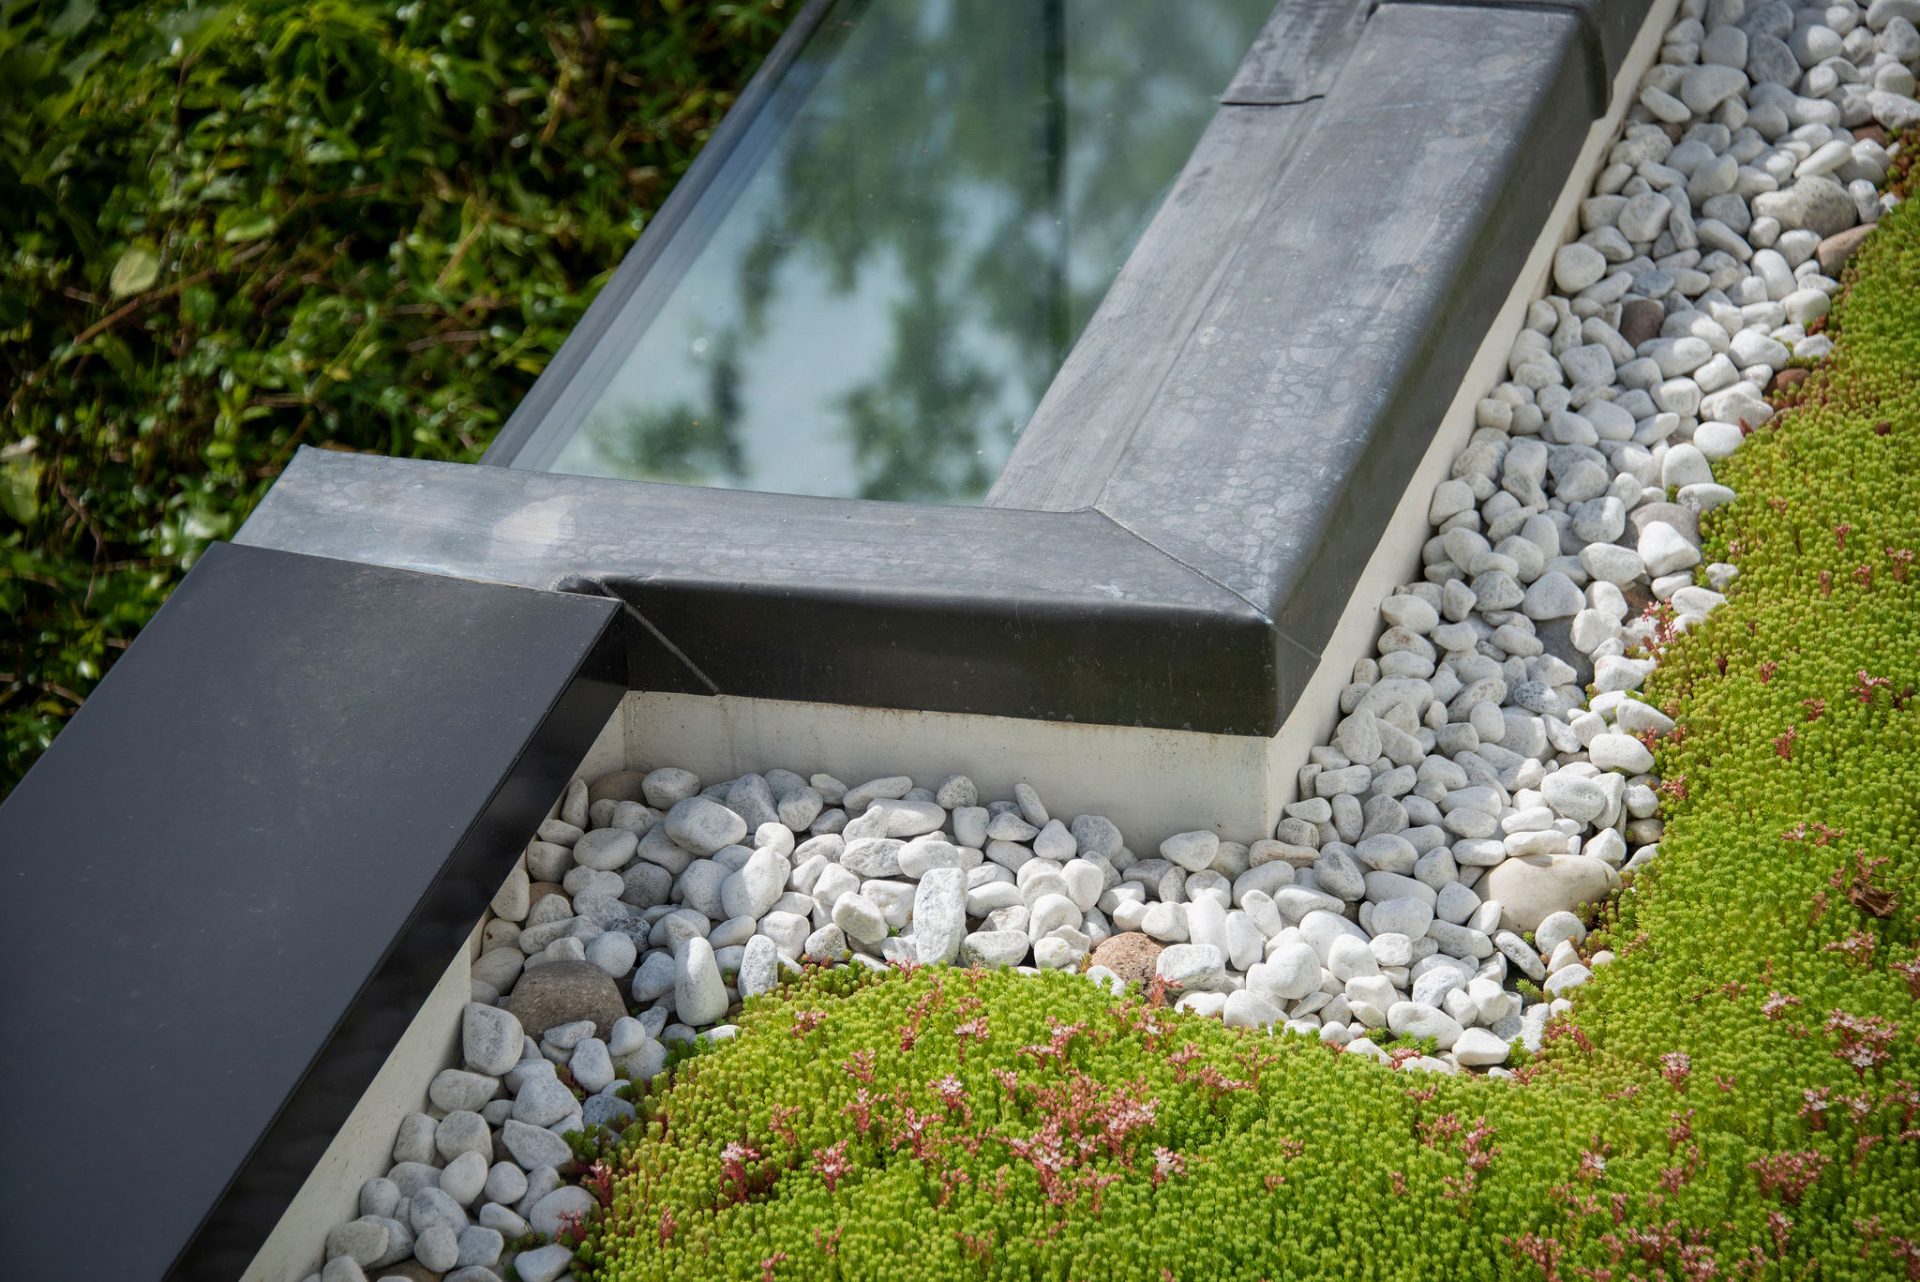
[238, 0, 1649, 735]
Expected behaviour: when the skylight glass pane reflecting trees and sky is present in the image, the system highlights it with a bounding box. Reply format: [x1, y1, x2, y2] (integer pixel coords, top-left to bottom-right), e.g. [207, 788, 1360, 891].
[536, 0, 1273, 503]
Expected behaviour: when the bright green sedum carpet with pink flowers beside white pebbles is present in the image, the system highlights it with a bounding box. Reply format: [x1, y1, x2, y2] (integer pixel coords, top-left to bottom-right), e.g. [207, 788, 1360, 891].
[560, 165, 1920, 1282]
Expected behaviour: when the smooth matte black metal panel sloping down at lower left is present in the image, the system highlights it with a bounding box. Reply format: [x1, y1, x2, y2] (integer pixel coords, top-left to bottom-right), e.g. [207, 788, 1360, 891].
[0, 545, 626, 1282]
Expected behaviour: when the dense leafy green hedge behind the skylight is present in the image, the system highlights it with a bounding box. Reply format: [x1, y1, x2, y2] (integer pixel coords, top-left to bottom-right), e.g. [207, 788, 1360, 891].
[0, 0, 797, 795]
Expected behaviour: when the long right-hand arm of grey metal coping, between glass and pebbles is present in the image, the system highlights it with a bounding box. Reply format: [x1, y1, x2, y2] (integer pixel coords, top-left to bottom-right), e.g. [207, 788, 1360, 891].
[1100, 6, 1590, 649]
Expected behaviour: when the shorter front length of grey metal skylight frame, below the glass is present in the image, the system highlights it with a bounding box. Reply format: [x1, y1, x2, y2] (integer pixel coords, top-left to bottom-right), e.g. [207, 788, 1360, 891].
[238, 451, 1279, 733]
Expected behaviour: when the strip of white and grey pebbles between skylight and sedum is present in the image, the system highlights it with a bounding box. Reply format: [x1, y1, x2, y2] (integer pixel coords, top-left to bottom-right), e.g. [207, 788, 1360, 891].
[307, 0, 1920, 1282]
